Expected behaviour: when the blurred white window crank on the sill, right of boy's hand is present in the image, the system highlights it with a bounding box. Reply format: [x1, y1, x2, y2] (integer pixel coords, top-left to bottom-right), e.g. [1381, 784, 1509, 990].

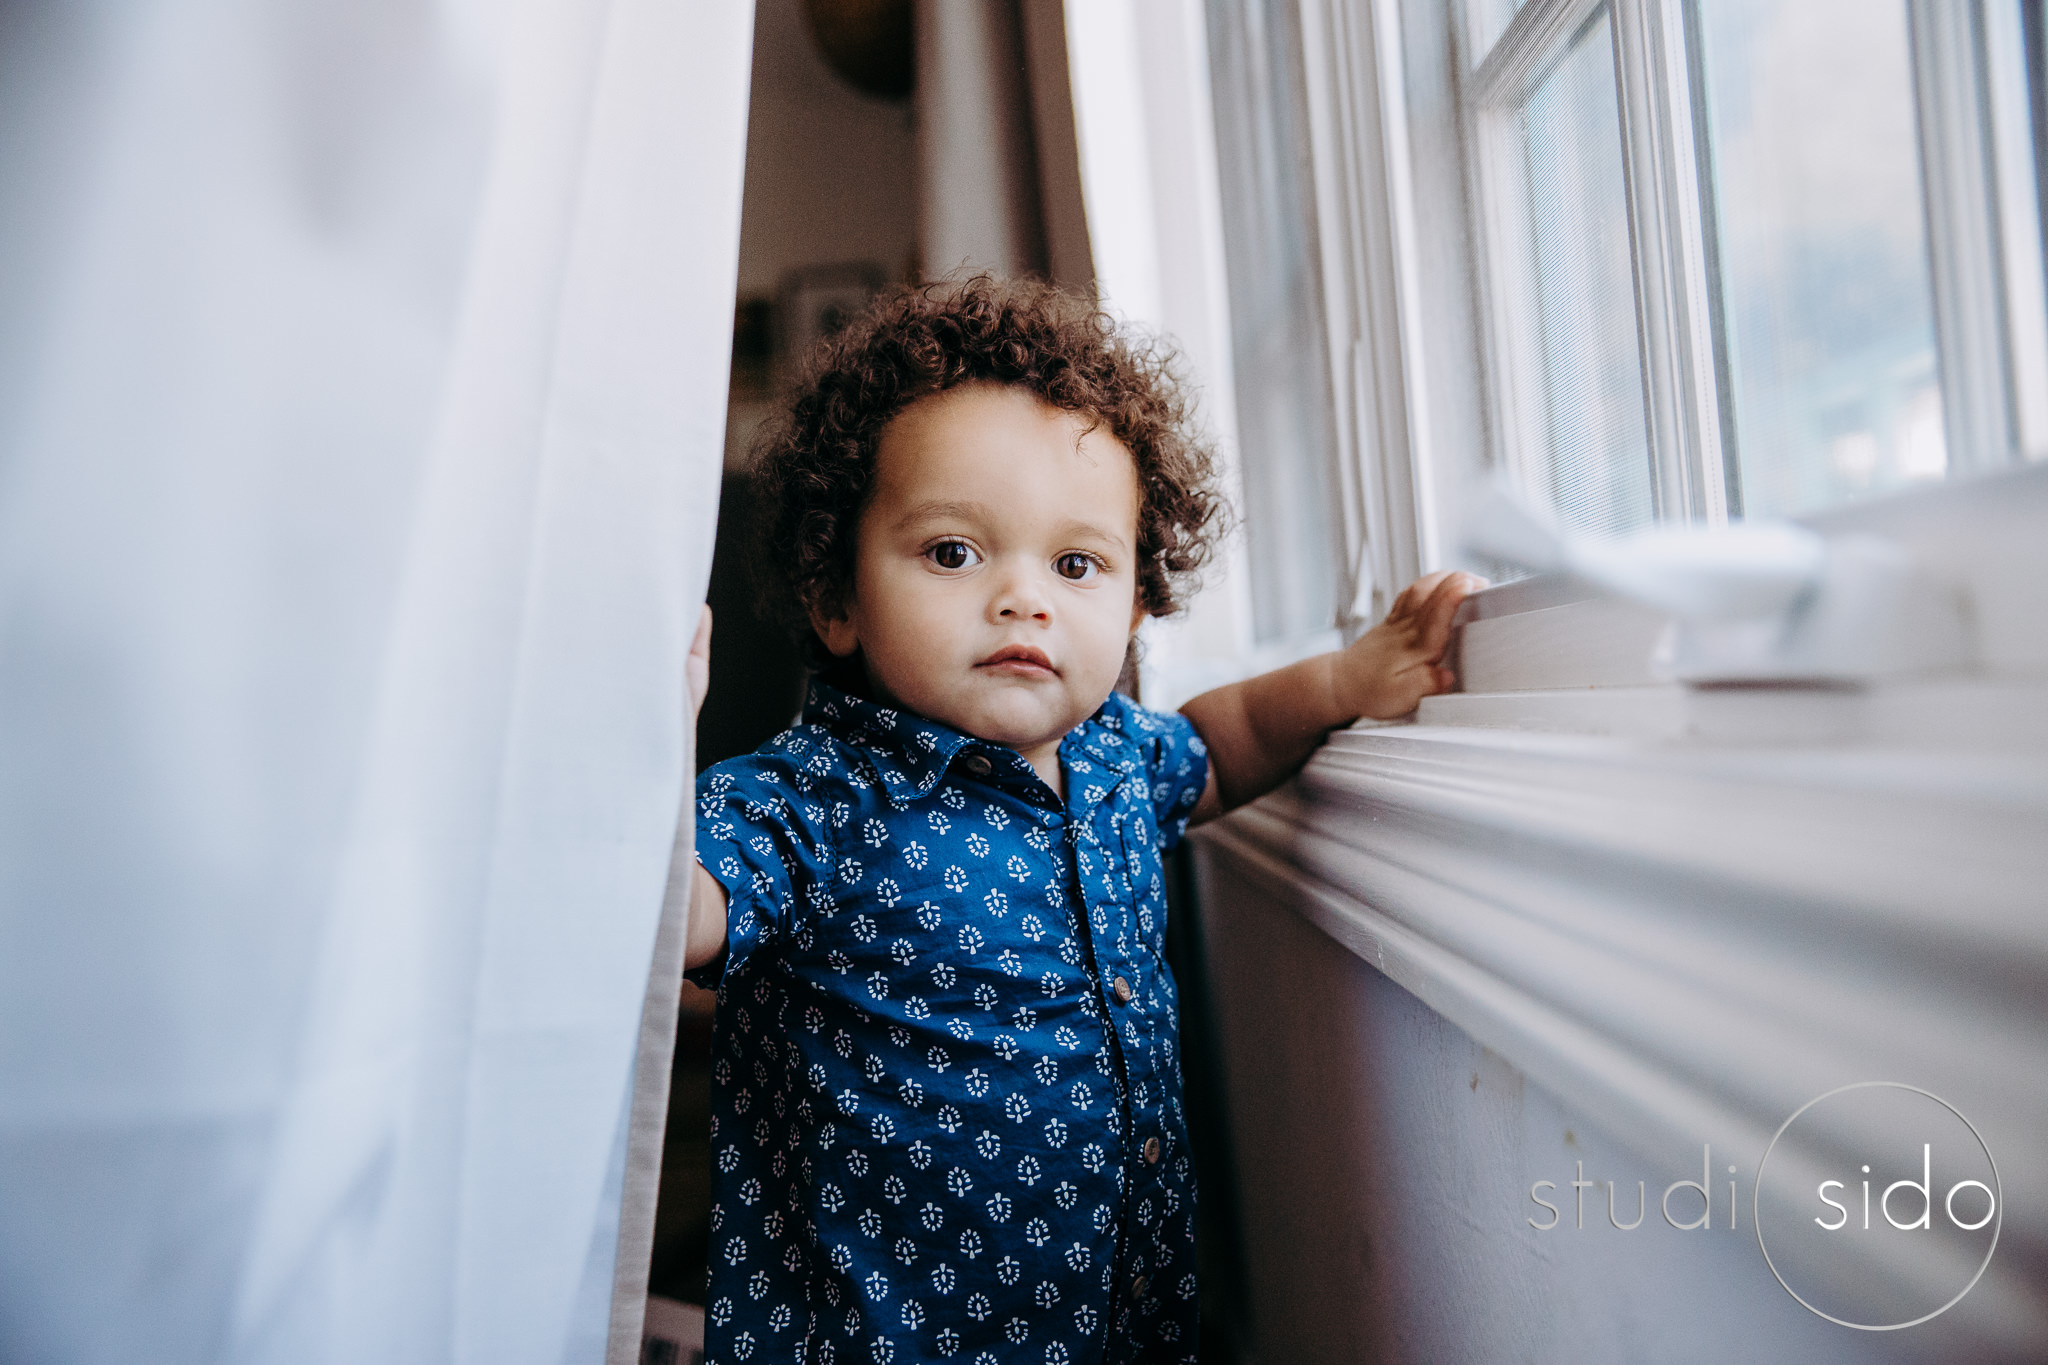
[1464, 489, 1970, 684]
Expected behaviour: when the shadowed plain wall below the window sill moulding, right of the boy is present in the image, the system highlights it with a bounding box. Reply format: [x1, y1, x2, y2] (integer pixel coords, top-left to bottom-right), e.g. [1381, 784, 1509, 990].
[1194, 837, 1985, 1365]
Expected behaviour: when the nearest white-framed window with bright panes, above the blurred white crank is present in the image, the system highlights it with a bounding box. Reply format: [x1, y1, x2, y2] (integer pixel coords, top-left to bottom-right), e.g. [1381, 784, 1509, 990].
[1458, 0, 2048, 532]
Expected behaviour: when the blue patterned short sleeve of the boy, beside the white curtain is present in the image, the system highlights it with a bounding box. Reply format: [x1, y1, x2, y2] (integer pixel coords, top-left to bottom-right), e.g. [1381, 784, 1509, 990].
[688, 751, 831, 986]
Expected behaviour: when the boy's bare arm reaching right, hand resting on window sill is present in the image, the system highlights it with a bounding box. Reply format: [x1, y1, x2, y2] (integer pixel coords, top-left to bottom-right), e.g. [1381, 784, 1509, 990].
[1180, 573, 1485, 825]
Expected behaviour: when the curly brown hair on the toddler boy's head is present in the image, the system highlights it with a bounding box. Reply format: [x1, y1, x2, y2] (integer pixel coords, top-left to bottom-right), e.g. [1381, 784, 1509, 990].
[754, 274, 1229, 632]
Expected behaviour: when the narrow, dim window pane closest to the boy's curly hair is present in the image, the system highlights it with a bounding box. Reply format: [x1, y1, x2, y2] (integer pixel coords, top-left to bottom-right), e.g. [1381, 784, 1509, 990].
[1208, 0, 1343, 641]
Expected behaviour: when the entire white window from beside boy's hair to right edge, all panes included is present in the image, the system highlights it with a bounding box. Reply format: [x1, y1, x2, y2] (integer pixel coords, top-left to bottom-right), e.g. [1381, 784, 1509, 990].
[1130, 0, 2048, 696]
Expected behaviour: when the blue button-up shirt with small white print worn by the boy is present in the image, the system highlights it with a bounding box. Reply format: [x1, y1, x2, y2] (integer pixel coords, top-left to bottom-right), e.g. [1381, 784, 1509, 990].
[692, 684, 1208, 1365]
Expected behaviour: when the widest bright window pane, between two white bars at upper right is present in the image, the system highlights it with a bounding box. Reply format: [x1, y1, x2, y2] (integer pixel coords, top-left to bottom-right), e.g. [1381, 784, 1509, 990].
[1696, 0, 1948, 518]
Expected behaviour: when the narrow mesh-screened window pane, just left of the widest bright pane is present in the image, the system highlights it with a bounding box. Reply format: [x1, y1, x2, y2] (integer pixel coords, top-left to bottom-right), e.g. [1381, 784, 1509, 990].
[1507, 8, 1655, 532]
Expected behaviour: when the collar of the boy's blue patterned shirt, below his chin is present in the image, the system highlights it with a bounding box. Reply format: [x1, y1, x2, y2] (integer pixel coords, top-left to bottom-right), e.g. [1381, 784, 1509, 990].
[803, 677, 1139, 808]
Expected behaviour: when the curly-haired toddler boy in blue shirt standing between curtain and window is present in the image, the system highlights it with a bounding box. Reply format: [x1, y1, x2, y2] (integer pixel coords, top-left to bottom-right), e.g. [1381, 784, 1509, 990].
[688, 278, 1477, 1365]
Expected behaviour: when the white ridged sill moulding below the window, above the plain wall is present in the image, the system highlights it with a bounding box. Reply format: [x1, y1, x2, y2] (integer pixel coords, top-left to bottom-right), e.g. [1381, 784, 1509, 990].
[1194, 720, 2048, 1342]
